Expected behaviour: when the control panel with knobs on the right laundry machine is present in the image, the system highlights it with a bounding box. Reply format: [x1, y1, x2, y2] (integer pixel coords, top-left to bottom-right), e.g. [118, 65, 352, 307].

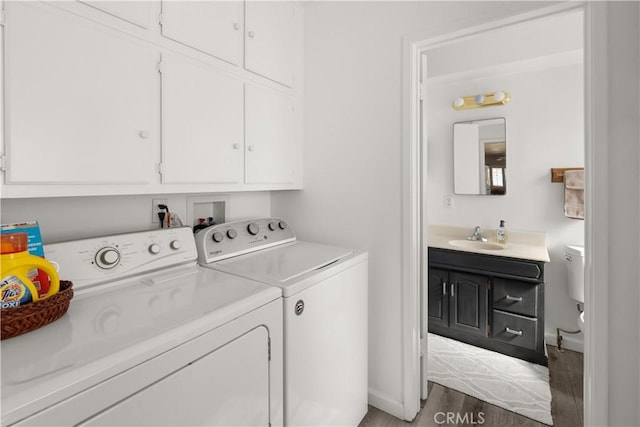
[195, 218, 296, 264]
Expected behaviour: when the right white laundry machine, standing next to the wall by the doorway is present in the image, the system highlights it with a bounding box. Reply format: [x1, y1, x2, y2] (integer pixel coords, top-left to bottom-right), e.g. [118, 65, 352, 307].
[196, 218, 368, 426]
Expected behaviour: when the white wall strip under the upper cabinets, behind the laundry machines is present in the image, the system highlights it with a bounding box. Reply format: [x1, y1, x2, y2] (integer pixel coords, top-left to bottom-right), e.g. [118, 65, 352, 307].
[0, 192, 270, 244]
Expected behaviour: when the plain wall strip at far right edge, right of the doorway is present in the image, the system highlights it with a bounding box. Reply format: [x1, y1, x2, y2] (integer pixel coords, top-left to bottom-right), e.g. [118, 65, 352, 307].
[596, 1, 640, 426]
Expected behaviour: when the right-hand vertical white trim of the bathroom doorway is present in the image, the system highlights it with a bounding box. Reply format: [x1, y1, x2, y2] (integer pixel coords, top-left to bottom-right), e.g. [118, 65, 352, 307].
[584, 2, 609, 426]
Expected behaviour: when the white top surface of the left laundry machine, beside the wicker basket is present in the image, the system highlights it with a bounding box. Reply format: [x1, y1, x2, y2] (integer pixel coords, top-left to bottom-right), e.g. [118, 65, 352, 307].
[2, 265, 281, 425]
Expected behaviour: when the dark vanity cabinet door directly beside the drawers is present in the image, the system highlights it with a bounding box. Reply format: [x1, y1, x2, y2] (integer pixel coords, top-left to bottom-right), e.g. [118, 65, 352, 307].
[449, 272, 489, 337]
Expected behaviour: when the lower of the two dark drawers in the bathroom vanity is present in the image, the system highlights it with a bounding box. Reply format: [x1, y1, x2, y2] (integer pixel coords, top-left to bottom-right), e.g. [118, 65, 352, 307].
[491, 310, 538, 350]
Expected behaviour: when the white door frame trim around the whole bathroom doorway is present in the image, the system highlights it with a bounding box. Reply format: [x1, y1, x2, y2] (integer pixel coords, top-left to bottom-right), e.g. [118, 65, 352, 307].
[402, 1, 596, 425]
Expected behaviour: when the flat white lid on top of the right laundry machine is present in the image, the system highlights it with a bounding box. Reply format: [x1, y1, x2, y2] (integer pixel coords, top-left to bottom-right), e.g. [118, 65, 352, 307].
[217, 241, 353, 286]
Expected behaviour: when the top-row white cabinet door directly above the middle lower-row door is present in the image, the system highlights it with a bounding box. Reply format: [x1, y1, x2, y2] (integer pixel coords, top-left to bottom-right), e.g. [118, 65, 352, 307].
[161, 0, 244, 65]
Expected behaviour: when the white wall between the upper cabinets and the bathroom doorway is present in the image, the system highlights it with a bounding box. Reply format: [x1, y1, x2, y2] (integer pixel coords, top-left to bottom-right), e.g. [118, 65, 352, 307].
[271, 2, 560, 417]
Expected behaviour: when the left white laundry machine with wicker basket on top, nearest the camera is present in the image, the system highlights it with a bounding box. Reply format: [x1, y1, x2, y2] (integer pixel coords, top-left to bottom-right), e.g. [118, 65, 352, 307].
[1, 227, 283, 426]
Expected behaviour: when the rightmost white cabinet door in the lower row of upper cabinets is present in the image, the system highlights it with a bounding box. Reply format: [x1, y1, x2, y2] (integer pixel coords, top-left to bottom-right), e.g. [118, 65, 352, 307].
[245, 85, 299, 184]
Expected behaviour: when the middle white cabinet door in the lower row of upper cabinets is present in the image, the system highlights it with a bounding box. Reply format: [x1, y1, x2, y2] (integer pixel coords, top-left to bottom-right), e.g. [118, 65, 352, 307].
[162, 55, 244, 183]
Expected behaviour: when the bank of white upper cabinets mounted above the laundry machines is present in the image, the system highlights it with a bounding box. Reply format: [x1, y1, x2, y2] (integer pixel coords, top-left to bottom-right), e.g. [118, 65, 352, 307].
[0, 0, 303, 198]
